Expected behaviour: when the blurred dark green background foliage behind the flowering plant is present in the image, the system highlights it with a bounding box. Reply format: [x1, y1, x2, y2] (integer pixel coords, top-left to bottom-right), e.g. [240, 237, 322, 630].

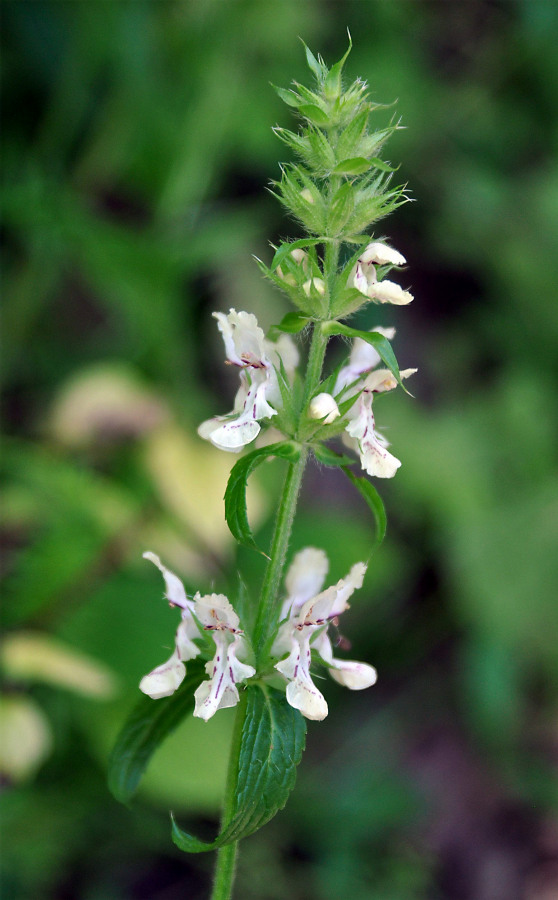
[0, 0, 558, 900]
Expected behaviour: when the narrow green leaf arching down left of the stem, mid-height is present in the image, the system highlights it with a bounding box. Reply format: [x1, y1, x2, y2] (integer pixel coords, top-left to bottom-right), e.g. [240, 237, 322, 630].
[225, 441, 300, 553]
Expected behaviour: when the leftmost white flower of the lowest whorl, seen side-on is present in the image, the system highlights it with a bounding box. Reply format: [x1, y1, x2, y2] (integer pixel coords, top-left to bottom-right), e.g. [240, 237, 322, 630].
[140, 552, 200, 700]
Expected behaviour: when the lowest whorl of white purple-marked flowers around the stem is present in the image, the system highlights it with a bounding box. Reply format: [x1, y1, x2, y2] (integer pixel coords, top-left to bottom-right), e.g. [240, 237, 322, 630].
[140, 547, 376, 721]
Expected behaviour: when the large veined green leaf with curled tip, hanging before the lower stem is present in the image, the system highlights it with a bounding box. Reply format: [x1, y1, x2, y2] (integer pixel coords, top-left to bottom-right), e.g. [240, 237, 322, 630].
[172, 684, 306, 853]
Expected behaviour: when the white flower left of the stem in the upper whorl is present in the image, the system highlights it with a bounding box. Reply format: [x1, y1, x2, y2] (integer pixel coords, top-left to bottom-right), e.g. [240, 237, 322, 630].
[198, 309, 298, 453]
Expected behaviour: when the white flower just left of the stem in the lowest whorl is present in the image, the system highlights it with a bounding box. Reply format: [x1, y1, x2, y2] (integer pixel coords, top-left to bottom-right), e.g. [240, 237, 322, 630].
[194, 594, 256, 722]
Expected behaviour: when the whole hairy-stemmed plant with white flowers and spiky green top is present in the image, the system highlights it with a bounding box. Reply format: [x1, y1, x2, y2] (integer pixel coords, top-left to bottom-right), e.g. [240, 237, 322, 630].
[110, 46, 416, 900]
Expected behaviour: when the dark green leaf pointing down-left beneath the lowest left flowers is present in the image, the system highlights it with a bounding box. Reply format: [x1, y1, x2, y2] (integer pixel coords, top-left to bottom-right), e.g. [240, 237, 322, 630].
[108, 662, 204, 803]
